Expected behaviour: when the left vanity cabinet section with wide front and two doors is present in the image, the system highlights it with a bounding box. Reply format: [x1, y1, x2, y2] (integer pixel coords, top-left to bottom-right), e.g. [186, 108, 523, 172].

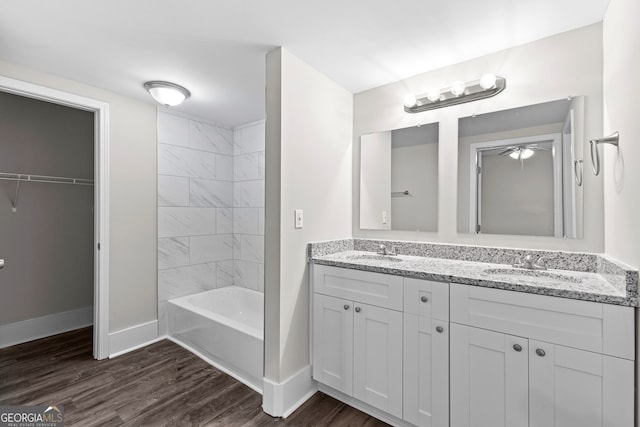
[313, 265, 403, 418]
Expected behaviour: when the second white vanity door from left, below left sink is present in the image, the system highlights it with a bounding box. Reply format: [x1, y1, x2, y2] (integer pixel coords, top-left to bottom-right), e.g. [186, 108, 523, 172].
[353, 303, 402, 418]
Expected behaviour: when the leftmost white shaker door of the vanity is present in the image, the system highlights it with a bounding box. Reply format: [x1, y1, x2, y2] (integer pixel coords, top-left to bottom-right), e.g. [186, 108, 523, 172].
[313, 294, 353, 395]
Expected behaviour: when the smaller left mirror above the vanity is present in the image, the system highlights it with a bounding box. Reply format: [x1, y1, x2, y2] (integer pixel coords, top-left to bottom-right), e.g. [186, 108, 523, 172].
[360, 123, 438, 231]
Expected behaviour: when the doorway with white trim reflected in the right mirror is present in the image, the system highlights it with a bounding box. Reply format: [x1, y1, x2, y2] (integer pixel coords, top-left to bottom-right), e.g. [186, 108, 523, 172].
[469, 134, 563, 237]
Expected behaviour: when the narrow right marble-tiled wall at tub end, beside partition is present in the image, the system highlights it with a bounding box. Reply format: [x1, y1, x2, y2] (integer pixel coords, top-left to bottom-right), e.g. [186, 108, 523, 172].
[232, 122, 265, 292]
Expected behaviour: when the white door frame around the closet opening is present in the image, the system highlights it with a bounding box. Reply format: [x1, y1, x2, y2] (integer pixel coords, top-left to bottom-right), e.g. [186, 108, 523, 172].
[0, 76, 109, 360]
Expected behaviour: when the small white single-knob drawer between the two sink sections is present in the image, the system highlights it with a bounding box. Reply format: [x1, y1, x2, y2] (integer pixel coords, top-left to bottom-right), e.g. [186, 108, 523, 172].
[404, 277, 449, 321]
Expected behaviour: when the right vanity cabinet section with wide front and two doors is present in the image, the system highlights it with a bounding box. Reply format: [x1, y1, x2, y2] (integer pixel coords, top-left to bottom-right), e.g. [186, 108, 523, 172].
[450, 284, 635, 427]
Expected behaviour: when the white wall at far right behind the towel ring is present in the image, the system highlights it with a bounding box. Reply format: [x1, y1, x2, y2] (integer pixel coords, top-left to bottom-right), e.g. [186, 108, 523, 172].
[604, 0, 640, 268]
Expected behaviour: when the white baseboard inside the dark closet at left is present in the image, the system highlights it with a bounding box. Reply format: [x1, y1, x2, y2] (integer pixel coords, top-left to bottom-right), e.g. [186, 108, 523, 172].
[0, 306, 93, 348]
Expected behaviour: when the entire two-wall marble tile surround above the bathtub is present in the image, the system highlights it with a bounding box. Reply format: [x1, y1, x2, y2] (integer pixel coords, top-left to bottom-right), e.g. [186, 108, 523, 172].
[158, 112, 264, 333]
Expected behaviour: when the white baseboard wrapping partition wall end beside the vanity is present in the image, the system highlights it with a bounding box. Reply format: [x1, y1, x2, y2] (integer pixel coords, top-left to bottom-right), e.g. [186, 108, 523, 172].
[262, 365, 318, 418]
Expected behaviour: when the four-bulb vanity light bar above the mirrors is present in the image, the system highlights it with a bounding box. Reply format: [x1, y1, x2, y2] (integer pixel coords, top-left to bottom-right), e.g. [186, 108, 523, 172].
[404, 74, 507, 113]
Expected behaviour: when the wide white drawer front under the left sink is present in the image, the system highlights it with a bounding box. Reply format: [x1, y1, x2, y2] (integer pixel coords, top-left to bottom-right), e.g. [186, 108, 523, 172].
[313, 264, 403, 311]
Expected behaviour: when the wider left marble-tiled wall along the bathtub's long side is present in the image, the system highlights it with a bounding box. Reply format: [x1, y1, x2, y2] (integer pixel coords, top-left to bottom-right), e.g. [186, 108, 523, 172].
[158, 112, 236, 334]
